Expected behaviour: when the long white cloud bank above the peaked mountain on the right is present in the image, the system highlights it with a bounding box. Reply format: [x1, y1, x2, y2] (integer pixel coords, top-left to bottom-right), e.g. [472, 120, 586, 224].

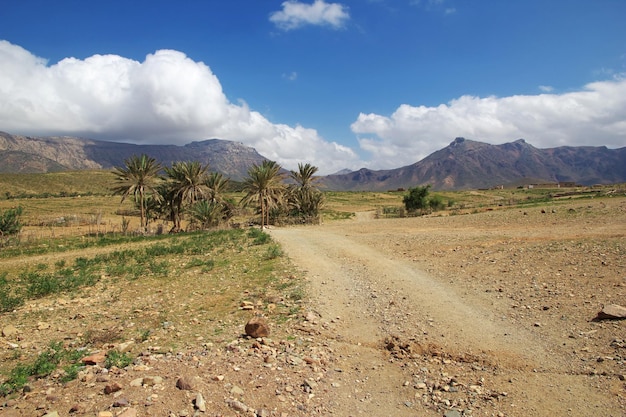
[351, 76, 626, 168]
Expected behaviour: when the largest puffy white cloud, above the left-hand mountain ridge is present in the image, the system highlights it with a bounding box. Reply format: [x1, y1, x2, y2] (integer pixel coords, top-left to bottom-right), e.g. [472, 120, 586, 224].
[0, 40, 359, 173]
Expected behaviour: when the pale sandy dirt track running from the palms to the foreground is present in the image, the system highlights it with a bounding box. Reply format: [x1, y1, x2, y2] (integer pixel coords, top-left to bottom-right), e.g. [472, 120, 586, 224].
[271, 214, 619, 416]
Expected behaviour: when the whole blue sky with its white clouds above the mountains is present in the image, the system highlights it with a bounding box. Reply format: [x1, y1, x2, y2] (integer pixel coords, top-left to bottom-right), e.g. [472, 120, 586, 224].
[0, 0, 626, 174]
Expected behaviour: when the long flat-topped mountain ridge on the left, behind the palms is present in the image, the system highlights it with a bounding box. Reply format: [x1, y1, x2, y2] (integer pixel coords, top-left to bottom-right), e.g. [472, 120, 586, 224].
[0, 132, 266, 180]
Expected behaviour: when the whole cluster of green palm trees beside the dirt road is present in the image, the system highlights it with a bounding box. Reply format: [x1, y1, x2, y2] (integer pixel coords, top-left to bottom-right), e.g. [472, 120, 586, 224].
[113, 154, 323, 232]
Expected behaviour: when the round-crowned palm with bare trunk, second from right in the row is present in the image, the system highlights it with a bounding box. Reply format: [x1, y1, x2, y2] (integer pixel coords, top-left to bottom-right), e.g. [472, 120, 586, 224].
[241, 160, 285, 229]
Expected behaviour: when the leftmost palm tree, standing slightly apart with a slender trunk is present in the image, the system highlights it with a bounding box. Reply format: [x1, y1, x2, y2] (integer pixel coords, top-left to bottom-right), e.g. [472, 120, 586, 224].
[113, 154, 161, 227]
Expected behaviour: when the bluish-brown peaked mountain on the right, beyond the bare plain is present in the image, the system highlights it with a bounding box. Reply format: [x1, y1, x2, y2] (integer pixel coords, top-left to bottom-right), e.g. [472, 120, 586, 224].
[322, 138, 626, 191]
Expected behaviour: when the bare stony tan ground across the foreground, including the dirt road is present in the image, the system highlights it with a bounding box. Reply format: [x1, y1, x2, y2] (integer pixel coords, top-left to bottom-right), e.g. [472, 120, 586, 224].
[0, 197, 626, 417]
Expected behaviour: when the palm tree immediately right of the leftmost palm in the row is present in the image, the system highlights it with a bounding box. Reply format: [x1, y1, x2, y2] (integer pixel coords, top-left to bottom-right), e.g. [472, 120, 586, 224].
[165, 161, 209, 231]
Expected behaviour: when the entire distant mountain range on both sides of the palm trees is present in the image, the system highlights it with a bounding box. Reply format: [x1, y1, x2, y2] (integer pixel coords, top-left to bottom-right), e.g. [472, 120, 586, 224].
[0, 132, 626, 191]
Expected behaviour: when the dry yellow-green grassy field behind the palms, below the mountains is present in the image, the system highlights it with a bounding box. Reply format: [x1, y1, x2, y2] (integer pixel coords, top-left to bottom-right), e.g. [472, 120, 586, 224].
[0, 171, 624, 234]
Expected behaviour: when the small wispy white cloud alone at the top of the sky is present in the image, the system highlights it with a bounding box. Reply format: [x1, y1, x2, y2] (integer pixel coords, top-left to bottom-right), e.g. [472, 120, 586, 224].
[270, 0, 350, 30]
